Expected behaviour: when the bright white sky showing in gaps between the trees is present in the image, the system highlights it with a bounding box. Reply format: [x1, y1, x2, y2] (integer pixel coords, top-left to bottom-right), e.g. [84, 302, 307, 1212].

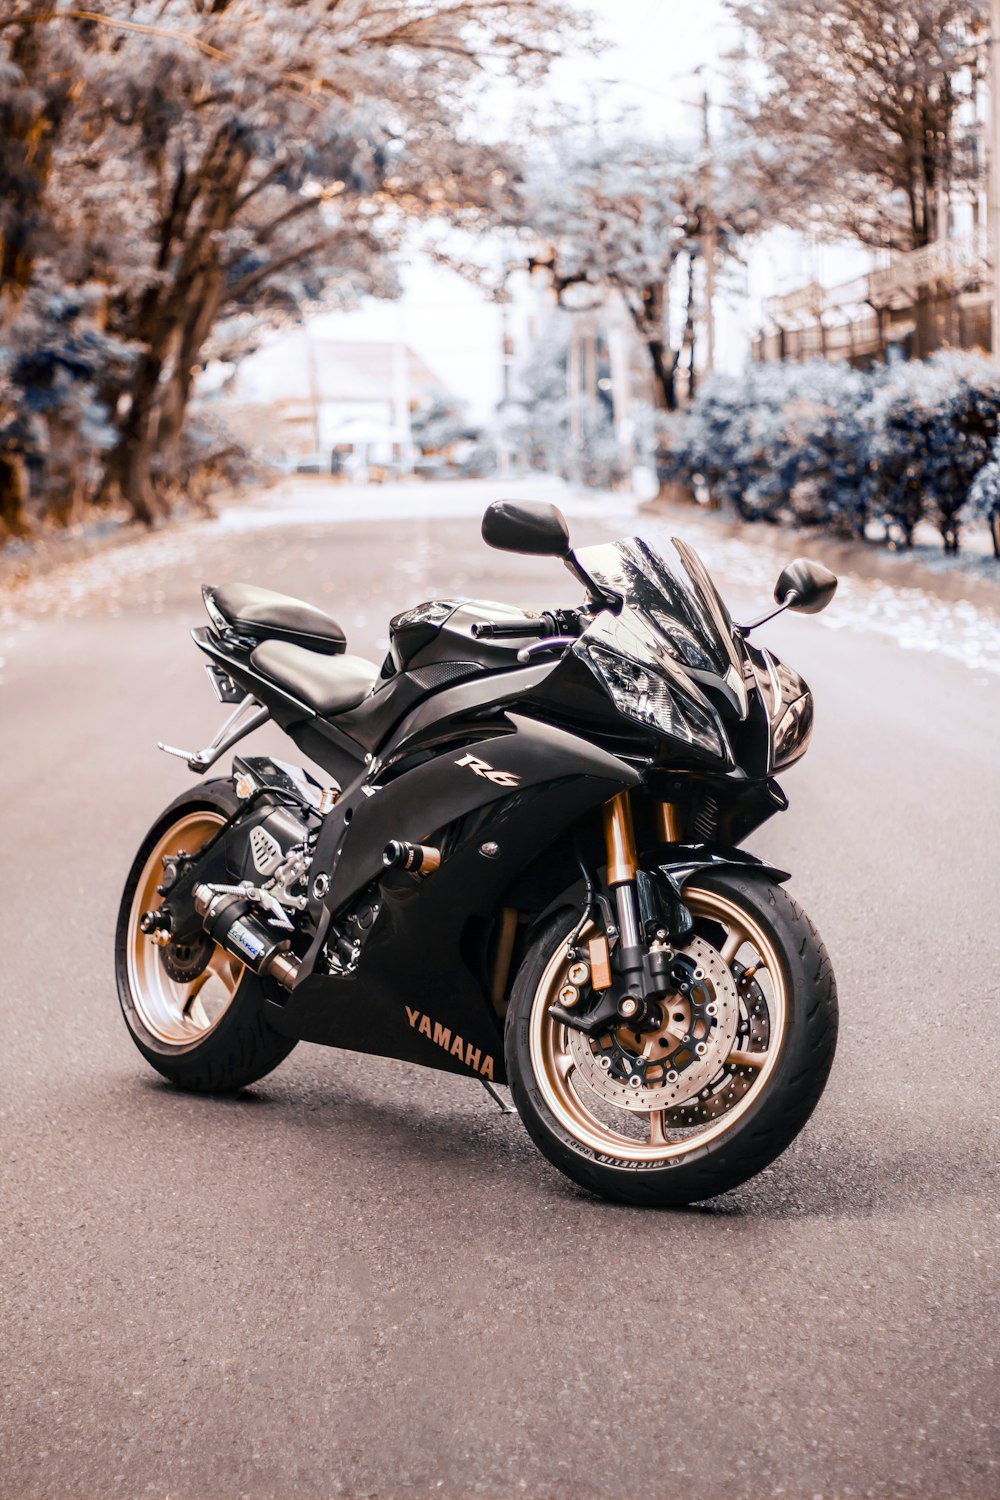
[313, 0, 855, 419]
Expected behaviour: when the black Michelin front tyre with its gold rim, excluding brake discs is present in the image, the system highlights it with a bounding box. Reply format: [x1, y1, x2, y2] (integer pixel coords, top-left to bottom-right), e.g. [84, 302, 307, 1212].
[505, 870, 838, 1206]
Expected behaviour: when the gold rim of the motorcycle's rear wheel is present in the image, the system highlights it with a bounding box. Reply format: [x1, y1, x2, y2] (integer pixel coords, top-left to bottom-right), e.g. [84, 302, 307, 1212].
[126, 810, 246, 1050]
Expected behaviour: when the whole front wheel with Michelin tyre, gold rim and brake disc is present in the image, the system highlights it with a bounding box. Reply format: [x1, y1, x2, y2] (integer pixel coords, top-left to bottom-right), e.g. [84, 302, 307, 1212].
[505, 870, 837, 1206]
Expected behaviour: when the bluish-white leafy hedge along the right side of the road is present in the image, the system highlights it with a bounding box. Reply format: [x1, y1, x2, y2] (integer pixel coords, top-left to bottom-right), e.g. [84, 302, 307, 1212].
[669, 353, 1000, 552]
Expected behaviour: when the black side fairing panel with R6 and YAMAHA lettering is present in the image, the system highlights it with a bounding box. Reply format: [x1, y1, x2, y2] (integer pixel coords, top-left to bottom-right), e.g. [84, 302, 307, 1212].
[271, 719, 639, 1082]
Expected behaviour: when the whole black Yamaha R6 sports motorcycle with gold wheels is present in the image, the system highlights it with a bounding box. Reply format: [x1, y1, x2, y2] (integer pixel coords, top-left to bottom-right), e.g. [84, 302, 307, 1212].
[115, 501, 837, 1205]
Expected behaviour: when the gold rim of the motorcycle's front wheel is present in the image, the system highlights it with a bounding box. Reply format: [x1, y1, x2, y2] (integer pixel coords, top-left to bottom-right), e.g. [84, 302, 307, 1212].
[529, 890, 787, 1163]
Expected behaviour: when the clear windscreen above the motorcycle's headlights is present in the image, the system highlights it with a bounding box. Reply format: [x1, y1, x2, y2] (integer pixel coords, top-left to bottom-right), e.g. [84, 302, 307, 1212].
[577, 537, 739, 677]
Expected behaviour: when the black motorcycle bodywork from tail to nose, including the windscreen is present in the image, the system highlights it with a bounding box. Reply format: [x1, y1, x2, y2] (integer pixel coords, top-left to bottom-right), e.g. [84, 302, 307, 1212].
[179, 516, 808, 1080]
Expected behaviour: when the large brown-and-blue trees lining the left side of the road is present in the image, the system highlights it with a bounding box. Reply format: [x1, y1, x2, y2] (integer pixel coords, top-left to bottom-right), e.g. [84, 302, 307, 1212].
[0, 0, 580, 536]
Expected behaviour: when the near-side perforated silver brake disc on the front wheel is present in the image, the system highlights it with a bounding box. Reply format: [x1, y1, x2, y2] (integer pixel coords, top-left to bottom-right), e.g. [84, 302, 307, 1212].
[567, 938, 741, 1113]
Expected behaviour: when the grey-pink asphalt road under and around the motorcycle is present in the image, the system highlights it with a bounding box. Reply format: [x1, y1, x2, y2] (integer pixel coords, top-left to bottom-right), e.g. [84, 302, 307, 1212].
[0, 483, 1000, 1500]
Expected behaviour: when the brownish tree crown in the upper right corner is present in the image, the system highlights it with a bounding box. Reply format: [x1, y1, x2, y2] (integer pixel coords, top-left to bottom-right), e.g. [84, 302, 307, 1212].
[730, 0, 985, 251]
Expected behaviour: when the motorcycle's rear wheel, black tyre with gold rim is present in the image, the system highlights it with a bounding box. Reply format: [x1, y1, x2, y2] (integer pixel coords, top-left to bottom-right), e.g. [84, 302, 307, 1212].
[114, 779, 295, 1094]
